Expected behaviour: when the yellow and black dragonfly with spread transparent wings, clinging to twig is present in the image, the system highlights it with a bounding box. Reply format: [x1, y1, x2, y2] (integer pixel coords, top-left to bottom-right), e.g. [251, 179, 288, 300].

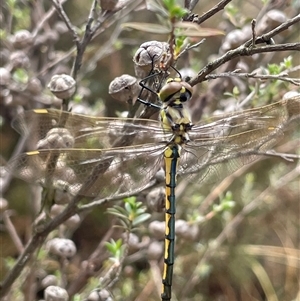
[8, 76, 300, 301]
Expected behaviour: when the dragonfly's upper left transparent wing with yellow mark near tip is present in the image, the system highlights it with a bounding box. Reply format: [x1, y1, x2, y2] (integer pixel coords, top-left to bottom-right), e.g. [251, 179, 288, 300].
[12, 109, 172, 149]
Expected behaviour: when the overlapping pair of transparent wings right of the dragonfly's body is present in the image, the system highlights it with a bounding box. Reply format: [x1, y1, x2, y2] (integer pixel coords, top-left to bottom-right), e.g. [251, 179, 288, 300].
[178, 96, 300, 182]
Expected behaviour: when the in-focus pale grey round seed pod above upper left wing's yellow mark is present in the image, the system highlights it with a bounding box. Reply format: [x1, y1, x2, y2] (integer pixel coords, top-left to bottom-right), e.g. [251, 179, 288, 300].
[48, 74, 76, 99]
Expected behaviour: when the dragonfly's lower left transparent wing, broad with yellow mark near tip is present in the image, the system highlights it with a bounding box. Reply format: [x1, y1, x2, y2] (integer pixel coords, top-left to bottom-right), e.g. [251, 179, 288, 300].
[8, 144, 165, 198]
